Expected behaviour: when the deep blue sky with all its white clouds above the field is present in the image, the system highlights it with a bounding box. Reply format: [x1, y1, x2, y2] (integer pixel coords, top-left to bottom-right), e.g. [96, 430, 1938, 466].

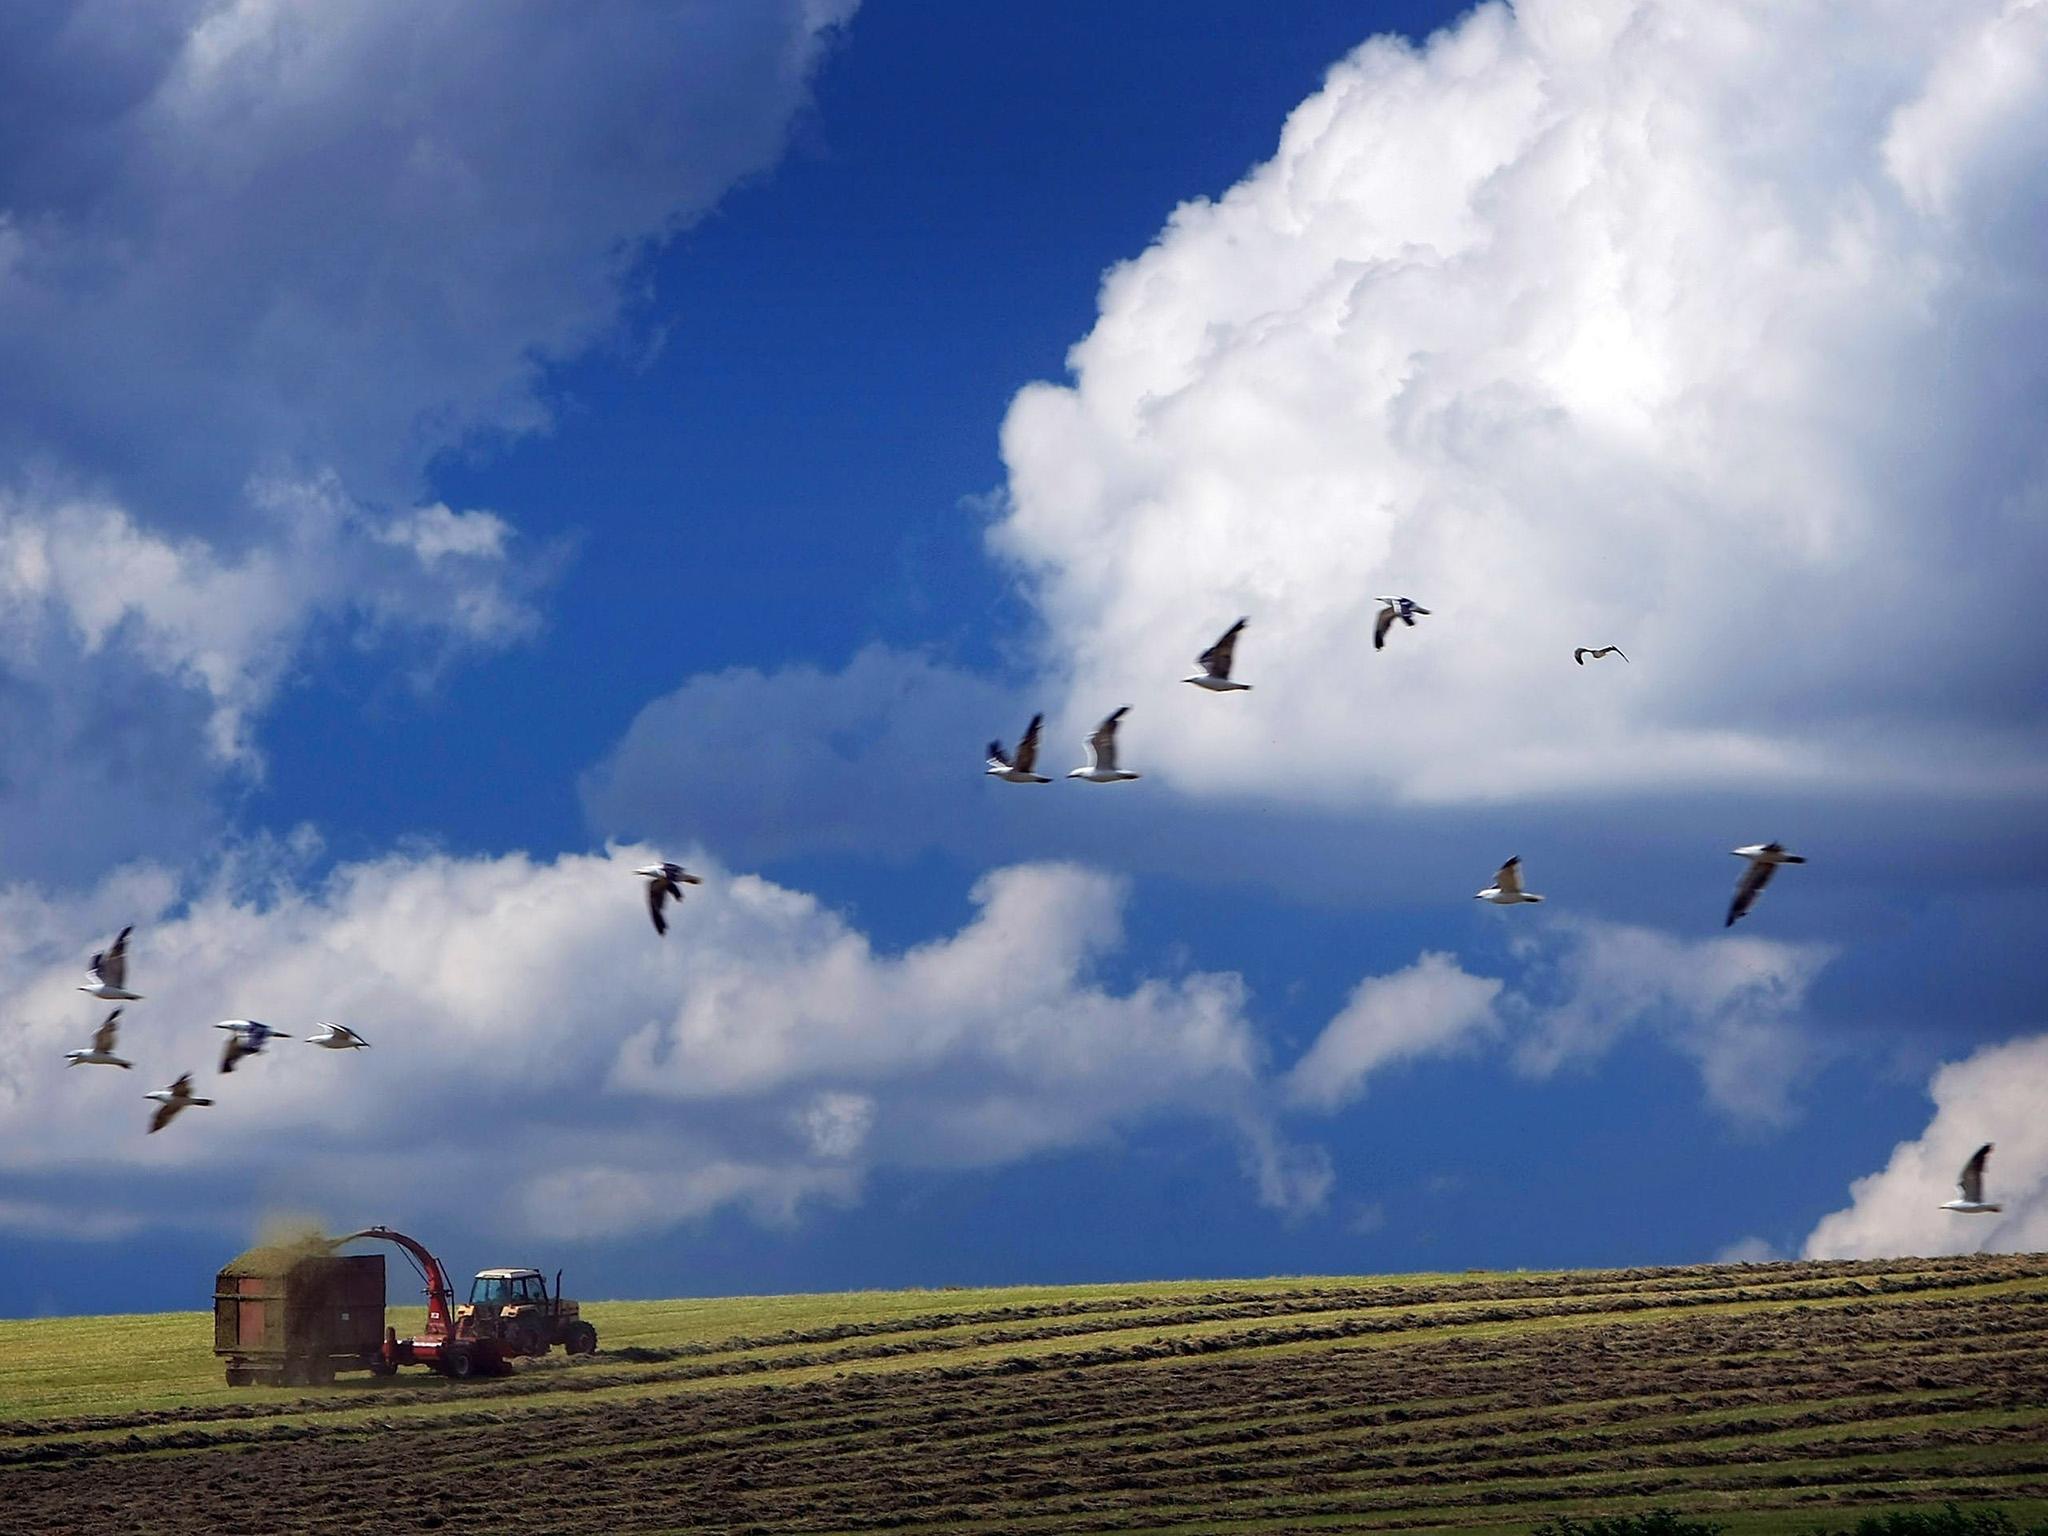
[0, 0, 2048, 1313]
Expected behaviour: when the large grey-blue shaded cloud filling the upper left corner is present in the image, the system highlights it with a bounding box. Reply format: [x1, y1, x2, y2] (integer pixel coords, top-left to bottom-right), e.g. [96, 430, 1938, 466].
[0, 0, 856, 874]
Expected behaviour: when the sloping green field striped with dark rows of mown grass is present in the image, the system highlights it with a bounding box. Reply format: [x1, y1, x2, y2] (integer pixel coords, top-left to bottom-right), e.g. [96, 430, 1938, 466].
[0, 1255, 2048, 1536]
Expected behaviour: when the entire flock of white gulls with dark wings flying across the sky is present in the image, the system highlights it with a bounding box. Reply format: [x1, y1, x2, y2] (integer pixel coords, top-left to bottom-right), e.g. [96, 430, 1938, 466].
[66, 596, 2003, 1214]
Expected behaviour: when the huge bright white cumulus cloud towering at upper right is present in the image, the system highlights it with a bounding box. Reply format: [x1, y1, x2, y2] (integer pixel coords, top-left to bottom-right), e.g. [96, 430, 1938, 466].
[991, 0, 2048, 811]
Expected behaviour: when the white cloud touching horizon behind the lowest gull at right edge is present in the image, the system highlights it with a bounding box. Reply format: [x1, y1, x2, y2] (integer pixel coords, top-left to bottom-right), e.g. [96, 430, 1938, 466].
[1806, 1034, 2048, 1257]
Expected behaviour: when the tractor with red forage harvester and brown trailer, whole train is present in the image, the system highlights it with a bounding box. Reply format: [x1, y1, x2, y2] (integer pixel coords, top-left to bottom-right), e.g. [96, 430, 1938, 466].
[213, 1227, 598, 1386]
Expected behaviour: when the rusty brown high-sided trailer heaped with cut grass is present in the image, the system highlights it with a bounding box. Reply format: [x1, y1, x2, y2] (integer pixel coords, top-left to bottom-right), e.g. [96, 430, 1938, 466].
[213, 1245, 391, 1386]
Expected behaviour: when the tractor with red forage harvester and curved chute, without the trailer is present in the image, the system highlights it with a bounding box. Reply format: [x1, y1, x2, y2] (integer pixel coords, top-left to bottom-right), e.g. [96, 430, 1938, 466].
[330, 1227, 598, 1380]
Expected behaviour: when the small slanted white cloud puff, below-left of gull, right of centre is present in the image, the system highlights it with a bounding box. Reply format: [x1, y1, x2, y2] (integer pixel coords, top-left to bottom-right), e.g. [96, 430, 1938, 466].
[1288, 950, 1503, 1110]
